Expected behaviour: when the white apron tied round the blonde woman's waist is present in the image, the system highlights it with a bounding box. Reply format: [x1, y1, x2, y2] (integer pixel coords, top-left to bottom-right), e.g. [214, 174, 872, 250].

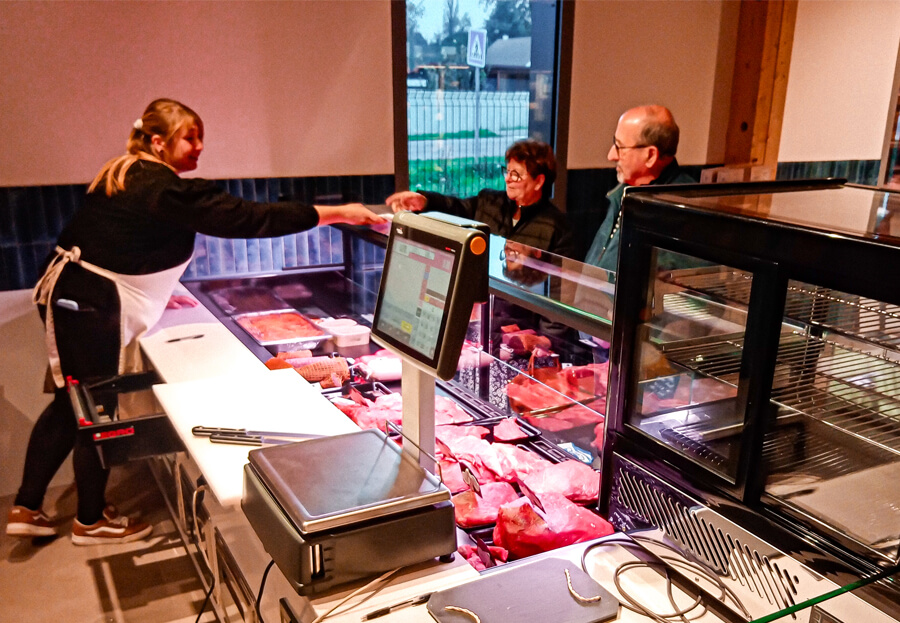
[32, 247, 190, 387]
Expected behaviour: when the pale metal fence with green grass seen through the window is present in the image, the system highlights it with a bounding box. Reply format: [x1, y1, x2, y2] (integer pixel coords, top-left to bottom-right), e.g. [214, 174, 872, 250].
[407, 89, 530, 197]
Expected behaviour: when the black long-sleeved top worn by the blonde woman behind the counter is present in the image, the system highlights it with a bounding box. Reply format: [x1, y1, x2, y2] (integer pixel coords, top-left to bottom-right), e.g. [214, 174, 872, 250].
[58, 160, 319, 275]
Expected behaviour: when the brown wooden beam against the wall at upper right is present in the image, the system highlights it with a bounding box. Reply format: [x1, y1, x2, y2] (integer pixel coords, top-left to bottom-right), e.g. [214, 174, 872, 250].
[725, 0, 797, 167]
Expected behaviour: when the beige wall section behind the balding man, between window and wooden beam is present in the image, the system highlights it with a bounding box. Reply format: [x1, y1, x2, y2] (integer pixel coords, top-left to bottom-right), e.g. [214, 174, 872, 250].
[568, 0, 740, 169]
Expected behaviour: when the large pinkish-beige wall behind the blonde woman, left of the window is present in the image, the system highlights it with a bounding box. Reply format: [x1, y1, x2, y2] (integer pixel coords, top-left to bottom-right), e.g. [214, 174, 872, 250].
[0, 0, 394, 186]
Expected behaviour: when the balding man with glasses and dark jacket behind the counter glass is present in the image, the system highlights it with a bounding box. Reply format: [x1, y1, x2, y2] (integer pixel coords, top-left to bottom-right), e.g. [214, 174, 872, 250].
[584, 106, 696, 271]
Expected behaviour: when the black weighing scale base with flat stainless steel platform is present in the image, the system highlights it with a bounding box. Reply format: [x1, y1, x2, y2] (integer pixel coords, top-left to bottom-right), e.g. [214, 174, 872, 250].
[241, 430, 456, 595]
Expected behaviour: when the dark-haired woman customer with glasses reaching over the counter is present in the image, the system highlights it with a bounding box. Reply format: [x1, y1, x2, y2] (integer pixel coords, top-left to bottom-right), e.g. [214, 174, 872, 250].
[385, 139, 575, 257]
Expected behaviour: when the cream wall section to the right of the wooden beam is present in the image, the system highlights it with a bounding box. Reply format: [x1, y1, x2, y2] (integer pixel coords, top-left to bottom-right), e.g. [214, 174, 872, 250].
[779, 0, 900, 162]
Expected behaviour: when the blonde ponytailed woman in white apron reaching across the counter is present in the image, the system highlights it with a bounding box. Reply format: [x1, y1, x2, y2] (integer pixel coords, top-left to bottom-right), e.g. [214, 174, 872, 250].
[6, 99, 383, 545]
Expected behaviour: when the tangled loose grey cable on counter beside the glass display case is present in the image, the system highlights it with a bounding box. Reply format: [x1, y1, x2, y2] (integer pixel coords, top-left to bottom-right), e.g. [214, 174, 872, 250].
[581, 535, 751, 623]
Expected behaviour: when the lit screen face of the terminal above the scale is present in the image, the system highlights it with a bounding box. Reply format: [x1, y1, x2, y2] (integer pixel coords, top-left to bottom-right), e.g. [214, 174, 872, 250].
[378, 240, 456, 360]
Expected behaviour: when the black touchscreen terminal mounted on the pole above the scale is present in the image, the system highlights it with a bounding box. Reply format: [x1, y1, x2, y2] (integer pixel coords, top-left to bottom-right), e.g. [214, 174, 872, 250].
[372, 212, 488, 380]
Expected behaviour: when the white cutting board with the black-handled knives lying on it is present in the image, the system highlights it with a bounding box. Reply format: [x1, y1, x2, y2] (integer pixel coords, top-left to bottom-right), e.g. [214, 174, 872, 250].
[153, 370, 359, 505]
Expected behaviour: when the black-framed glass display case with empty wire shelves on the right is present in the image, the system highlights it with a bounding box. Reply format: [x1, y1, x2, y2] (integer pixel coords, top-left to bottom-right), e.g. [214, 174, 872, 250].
[600, 180, 900, 623]
